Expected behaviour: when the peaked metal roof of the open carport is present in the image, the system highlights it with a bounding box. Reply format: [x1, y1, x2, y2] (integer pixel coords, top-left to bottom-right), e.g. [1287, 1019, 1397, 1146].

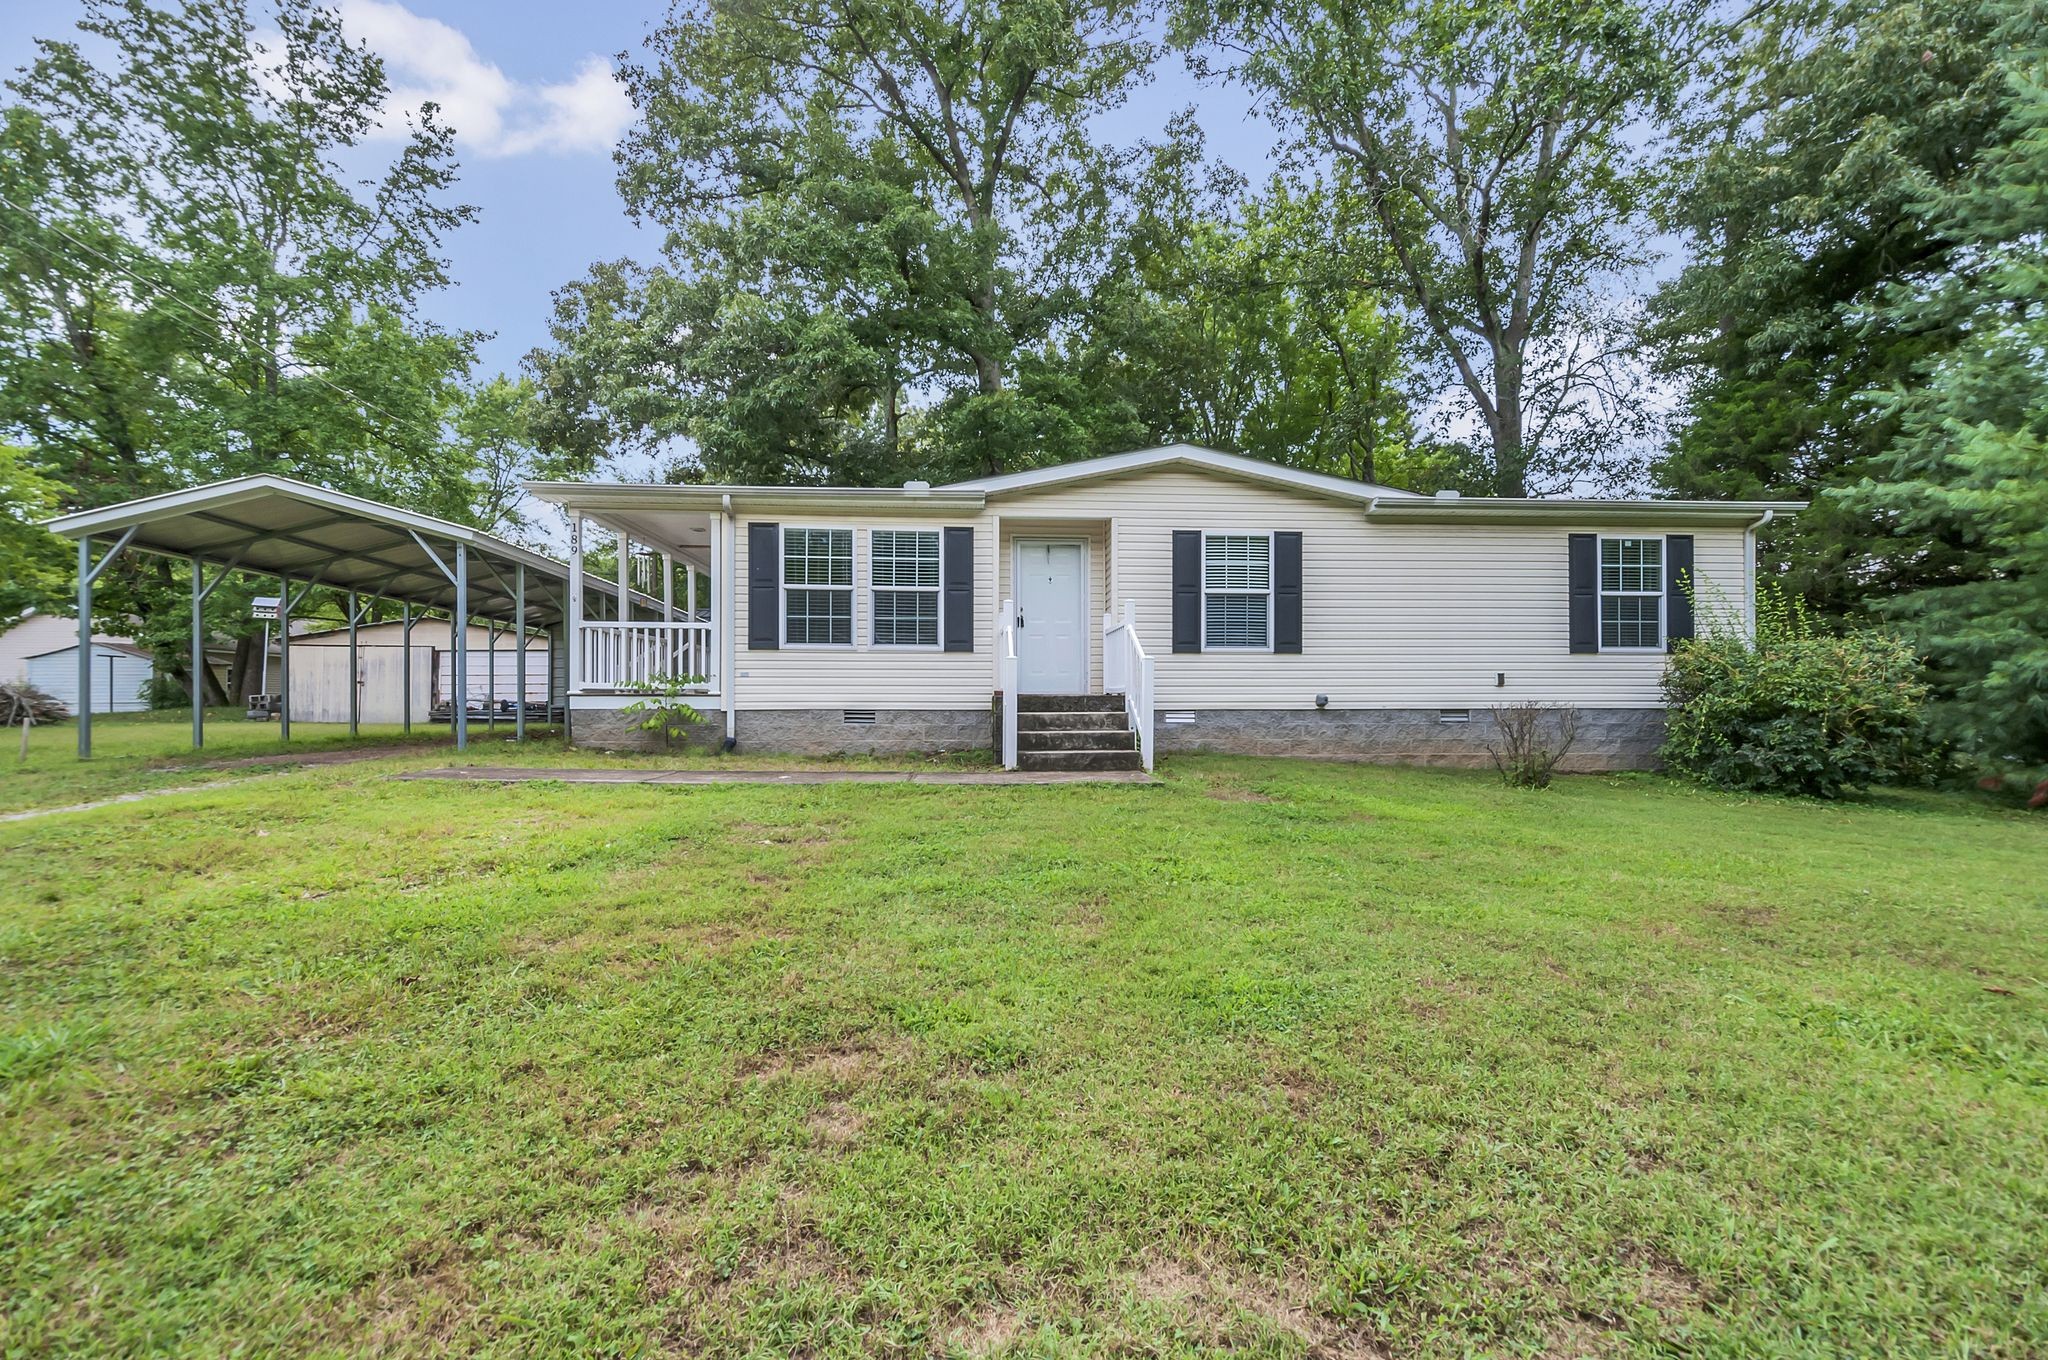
[47, 475, 647, 625]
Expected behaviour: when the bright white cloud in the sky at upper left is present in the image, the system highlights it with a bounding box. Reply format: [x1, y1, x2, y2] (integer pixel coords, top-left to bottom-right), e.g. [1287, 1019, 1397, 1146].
[338, 0, 633, 156]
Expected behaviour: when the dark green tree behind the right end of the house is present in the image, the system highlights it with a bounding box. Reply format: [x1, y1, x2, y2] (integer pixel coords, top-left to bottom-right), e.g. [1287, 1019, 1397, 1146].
[1649, 0, 2011, 617]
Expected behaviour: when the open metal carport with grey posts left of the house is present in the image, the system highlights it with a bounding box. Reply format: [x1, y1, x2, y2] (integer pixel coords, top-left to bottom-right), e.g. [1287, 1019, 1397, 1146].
[47, 475, 659, 758]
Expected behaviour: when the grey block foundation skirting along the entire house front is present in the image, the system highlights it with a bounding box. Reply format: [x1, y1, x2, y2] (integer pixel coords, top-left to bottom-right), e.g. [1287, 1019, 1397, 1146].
[571, 709, 1663, 770]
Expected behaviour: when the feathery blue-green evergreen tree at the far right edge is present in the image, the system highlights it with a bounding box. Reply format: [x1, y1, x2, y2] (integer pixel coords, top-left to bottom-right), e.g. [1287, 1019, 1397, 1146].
[1831, 0, 2048, 791]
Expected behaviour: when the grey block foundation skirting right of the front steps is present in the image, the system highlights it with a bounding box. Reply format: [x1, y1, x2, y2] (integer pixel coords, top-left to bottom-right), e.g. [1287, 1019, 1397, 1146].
[1153, 709, 1663, 770]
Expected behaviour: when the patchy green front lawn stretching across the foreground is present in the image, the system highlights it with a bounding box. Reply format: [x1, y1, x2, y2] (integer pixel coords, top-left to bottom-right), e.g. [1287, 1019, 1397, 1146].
[0, 749, 2048, 1358]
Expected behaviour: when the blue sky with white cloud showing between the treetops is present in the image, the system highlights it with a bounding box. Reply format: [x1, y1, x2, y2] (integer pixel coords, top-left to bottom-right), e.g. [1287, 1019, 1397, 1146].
[0, 0, 1274, 375]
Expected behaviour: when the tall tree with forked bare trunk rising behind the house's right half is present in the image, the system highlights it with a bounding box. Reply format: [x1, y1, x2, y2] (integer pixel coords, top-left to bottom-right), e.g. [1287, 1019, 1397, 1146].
[1178, 0, 1702, 496]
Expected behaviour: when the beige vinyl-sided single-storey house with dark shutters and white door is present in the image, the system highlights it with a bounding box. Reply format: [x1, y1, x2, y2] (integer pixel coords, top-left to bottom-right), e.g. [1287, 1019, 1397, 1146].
[532, 447, 1798, 768]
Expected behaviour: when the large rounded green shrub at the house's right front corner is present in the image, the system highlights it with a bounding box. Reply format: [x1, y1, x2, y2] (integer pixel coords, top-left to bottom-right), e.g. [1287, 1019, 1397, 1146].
[1663, 586, 1931, 799]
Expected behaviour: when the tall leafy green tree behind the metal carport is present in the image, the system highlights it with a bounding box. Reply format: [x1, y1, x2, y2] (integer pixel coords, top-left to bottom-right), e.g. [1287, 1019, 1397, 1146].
[0, 0, 473, 696]
